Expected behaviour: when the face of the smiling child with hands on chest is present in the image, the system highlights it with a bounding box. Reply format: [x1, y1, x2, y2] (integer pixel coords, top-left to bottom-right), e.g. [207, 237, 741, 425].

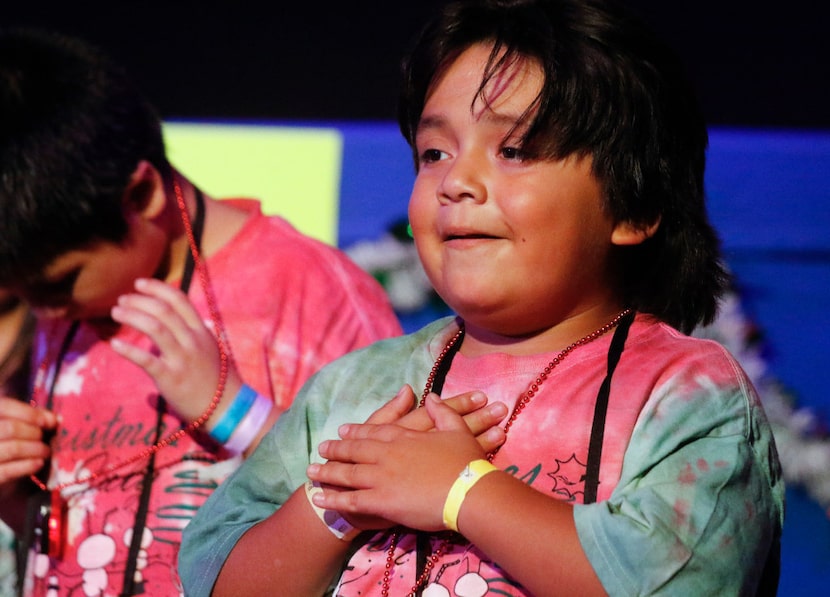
[409, 45, 616, 336]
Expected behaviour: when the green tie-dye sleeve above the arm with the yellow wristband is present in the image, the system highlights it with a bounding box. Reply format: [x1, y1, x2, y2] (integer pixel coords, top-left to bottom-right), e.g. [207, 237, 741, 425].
[574, 366, 784, 595]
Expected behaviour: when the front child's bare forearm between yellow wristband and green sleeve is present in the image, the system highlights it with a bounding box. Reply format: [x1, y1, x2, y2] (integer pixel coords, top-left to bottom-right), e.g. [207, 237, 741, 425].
[458, 471, 605, 596]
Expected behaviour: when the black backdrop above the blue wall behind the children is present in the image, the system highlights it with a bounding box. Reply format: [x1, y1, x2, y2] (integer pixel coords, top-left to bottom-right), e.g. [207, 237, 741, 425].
[0, 0, 830, 129]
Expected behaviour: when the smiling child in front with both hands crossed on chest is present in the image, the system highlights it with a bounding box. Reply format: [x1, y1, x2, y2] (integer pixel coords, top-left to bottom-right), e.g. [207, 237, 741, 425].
[180, 0, 783, 597]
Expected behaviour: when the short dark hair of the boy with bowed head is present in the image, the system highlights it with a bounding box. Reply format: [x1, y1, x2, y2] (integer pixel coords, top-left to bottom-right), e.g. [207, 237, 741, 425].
[0, 29, 169, 283]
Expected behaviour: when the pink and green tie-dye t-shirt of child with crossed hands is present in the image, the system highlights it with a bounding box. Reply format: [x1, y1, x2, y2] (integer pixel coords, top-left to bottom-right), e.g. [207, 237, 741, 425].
[180, 315, 783, 597]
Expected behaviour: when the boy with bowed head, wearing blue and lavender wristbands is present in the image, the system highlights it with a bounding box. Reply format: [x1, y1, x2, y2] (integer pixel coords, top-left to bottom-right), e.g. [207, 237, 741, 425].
[0, 30, 400, 597]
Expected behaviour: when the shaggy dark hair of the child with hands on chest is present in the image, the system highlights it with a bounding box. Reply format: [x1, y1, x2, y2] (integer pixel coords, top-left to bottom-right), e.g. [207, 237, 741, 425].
[398, 0, 728, 332]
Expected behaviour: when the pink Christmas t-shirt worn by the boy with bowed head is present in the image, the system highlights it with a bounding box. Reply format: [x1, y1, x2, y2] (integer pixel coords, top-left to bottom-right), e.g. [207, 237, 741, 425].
[25, 200, 400, 597]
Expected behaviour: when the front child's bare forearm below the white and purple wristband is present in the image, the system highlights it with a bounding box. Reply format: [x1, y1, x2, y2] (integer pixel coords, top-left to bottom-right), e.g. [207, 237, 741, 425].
[213, 488, 349, 597]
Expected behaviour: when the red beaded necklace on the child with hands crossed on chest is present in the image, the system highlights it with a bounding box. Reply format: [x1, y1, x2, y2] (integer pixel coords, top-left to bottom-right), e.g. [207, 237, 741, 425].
[381, 309, 631, 597]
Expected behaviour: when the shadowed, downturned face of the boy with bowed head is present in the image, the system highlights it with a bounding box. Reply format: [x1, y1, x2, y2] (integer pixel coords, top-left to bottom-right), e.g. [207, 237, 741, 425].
[14, 212, 167, 322]
